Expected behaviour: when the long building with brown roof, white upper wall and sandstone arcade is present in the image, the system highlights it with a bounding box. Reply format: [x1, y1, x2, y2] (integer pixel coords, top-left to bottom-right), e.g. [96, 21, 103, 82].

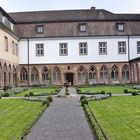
[6, 8, 140, 86]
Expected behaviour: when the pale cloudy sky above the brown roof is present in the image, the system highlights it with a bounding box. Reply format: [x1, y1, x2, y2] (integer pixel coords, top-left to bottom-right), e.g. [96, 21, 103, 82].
[0, 0, 140, 13]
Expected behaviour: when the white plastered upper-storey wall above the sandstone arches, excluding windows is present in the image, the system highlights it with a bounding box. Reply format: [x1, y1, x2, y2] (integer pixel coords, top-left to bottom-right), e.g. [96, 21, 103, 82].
[19, 36, 140, 64]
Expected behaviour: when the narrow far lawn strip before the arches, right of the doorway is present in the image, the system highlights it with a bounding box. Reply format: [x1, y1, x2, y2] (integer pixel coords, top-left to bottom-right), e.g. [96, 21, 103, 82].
[78, 86, 140, 94]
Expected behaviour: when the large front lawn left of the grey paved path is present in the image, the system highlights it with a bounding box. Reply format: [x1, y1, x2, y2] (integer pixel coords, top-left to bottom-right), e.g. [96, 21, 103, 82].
[0, 99, 45, 140]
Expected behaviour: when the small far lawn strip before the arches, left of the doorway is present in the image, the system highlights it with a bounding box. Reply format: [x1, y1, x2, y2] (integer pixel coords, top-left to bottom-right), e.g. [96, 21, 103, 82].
[15, 87, 59, 97]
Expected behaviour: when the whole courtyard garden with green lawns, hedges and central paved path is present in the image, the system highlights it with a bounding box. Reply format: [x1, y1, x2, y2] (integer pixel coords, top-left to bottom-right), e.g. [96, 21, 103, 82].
[0, 85, 140, 140]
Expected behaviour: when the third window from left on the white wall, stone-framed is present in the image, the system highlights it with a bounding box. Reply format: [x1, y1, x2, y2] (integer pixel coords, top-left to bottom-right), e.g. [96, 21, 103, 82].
[79, 42, 88, 55]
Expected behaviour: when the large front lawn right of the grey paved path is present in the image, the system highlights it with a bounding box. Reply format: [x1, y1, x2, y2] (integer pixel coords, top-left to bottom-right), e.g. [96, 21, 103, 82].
[89, 96, 140, 140]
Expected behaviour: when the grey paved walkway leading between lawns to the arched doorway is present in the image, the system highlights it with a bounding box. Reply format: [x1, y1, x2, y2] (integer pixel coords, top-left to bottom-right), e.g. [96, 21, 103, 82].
[25, 88, 95, 140]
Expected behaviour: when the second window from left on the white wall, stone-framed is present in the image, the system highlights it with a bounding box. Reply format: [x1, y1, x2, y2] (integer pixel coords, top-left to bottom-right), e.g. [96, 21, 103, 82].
[59, 43, 68, 56]
